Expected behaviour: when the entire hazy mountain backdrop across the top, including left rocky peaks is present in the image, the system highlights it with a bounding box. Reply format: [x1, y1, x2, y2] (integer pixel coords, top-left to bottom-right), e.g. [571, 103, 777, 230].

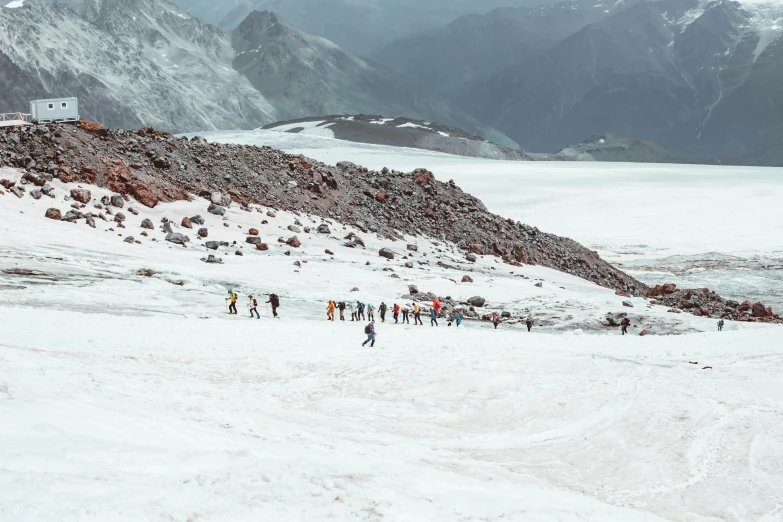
[0, 0, 783, 164]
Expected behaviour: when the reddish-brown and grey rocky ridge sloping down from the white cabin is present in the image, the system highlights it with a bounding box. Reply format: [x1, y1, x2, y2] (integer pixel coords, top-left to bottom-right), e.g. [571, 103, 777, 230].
[0, 122, 776, 316]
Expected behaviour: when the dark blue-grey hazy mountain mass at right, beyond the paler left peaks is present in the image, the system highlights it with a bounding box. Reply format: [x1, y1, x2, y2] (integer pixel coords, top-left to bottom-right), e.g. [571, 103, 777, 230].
[373, 0, 783, 161]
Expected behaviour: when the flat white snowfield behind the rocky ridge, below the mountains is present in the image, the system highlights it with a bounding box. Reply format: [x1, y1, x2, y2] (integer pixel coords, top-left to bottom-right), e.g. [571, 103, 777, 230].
[191, 131, 783, 310]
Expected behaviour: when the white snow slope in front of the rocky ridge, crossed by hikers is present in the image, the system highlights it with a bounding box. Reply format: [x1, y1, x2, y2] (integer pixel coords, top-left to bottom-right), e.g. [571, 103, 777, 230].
[0, 155, 783, 522]
